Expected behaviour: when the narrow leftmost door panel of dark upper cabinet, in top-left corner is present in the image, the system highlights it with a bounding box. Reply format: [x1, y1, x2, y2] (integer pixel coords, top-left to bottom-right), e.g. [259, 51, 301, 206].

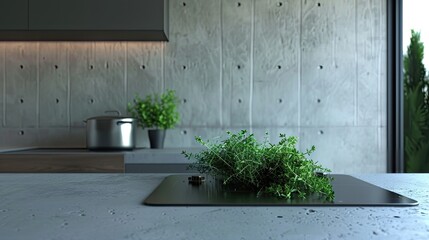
[0, 0, 28, 31]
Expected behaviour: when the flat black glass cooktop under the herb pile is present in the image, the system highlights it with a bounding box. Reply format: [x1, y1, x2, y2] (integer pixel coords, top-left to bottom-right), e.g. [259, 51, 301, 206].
[144, 174, 418, 206]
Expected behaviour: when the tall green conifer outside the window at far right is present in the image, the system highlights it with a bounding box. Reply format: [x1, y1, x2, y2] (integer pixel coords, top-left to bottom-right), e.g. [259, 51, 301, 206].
[404, 30, 429, 172]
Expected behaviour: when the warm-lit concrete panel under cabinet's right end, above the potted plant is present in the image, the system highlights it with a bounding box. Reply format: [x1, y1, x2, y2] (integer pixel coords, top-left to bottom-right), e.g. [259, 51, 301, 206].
[126, 42, 165, 102]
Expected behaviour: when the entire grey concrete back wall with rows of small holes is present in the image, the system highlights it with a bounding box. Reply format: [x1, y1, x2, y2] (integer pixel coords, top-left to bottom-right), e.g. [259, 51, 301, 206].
[0, 0, 386, 173]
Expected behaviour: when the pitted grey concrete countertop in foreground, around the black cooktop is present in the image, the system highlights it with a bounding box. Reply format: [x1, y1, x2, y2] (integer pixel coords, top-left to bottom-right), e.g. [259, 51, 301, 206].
[0, 174, 429, 240]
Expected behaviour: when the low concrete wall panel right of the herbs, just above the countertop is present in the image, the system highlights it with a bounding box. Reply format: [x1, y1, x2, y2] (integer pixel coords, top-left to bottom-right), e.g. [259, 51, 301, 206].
[301, 127, 386, 174]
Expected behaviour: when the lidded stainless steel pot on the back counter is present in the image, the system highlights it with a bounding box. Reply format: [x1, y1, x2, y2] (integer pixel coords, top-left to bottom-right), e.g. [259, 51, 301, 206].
[84, 112, 136, 150]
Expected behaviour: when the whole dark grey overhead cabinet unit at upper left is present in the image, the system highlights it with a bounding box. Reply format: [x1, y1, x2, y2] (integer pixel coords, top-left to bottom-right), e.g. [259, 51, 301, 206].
[0, 0, 168, 41]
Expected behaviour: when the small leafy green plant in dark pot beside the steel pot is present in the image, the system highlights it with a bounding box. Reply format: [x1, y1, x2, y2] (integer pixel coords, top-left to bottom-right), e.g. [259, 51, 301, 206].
[128, 90, 179, 148]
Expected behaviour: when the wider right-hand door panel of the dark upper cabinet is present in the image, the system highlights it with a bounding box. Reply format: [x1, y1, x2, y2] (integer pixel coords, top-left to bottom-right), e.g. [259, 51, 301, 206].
[30, 0, 164, 30]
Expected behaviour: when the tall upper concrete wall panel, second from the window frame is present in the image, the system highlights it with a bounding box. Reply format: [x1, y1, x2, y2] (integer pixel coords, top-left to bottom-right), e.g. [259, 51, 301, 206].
[300, 1, 356, 126]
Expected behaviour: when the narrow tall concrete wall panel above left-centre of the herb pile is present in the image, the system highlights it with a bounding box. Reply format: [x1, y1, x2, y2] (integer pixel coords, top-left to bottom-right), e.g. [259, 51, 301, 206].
[221, 0, 254, 127]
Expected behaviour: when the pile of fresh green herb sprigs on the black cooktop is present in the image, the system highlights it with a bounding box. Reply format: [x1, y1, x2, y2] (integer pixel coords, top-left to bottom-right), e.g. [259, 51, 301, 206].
[183, 130, 334, 201]
